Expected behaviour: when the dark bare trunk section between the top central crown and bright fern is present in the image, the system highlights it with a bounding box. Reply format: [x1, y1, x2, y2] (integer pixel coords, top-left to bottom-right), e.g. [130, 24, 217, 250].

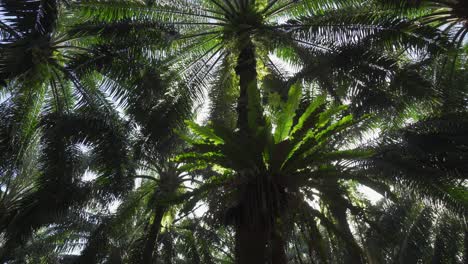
[236, 39, 257, 133]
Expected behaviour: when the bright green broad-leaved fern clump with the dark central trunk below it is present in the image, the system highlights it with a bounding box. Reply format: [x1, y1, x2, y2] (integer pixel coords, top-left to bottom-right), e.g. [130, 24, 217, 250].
[179, 82, 371, 263]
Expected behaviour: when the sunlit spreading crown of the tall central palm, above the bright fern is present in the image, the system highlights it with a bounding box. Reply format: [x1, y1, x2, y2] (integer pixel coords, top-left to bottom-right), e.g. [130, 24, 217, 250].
[67, 0, 443, 129]
